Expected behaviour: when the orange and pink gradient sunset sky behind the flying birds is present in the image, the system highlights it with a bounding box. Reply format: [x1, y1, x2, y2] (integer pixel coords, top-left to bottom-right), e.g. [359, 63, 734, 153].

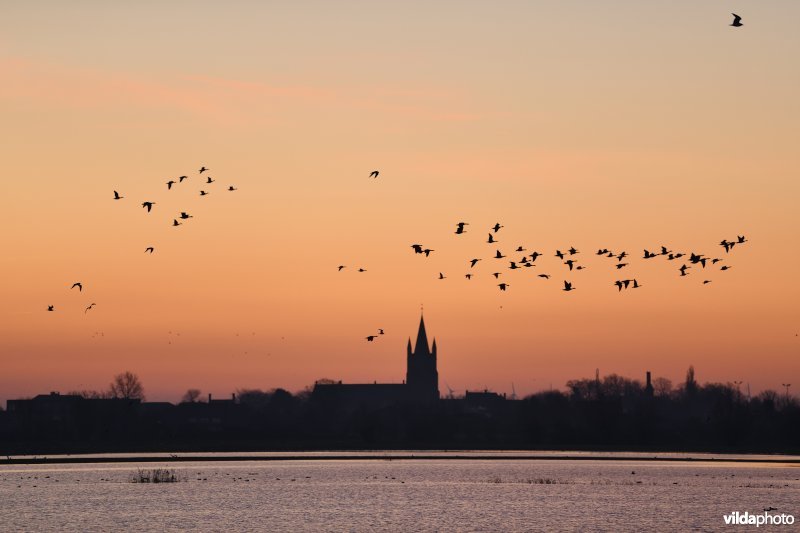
[0, 0, 800, 401]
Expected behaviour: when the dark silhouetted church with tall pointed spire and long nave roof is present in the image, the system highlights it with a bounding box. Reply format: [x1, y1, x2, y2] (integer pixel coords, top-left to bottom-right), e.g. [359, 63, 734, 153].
[312, 317, 439, 410]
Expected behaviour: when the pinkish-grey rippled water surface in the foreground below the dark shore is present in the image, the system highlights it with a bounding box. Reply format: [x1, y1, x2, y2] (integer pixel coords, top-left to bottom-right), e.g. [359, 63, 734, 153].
[0, 452, 800, 531]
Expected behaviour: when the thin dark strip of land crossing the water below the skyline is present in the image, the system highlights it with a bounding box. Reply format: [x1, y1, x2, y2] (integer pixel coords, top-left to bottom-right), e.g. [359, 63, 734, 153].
[0, 452, 800, 465]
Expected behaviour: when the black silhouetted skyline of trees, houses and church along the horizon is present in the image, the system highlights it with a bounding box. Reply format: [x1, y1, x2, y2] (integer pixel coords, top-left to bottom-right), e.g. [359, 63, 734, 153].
[0, 314, 800, 455]
